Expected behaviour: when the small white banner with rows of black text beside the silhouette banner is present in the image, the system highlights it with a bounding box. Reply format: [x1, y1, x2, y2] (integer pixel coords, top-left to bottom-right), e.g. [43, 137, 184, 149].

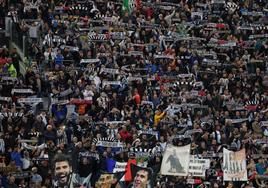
[189, 155, 210, 177]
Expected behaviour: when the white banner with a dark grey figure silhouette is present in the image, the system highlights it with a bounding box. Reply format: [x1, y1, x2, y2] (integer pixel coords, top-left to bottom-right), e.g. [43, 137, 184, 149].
[160, 144, 190, 176]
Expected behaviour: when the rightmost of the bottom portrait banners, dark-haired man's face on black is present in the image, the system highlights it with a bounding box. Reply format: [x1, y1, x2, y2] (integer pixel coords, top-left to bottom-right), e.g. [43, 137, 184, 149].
[128, 164, 155, 188]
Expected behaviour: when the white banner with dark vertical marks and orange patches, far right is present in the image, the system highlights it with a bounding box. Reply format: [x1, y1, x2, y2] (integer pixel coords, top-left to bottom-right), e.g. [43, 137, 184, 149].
[222, 148, 248, 181]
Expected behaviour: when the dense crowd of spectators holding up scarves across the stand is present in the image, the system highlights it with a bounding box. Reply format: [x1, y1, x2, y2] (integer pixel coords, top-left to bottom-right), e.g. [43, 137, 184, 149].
[0, 0, 268, 188]
